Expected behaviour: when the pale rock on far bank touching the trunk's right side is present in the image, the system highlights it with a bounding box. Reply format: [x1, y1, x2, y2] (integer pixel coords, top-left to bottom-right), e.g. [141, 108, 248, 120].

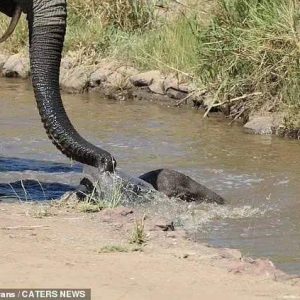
[60, 66, 91, 93]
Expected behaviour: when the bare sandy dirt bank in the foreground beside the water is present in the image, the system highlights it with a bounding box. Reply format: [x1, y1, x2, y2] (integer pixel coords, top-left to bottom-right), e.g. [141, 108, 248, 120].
[0, 203, 300, 300]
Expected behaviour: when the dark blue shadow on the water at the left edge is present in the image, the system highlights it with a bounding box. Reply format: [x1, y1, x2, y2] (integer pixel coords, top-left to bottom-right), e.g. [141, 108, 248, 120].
[0, 157, 82, 201]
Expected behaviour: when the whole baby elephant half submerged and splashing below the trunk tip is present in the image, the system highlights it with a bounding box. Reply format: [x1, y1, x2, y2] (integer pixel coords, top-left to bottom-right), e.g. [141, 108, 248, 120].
[77, 166, 225, 204]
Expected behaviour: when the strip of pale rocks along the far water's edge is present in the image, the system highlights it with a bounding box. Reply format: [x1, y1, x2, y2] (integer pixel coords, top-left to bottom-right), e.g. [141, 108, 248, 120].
[0, 53, 300, 140]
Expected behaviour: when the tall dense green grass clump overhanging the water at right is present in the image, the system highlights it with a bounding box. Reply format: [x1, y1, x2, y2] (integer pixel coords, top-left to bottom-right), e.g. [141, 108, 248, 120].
[197, 0, 300, 125]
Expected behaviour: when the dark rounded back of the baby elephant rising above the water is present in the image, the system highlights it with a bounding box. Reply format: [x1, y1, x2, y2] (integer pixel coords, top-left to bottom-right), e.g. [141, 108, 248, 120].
[139, 169, 225, 204]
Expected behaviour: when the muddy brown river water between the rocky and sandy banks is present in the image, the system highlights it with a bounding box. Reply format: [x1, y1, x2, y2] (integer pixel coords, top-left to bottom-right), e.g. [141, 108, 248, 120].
[0, 78, 300, 275]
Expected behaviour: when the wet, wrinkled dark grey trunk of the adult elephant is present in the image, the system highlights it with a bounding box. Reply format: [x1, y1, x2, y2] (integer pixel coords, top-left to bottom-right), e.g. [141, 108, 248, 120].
[27, 0, 116, 172]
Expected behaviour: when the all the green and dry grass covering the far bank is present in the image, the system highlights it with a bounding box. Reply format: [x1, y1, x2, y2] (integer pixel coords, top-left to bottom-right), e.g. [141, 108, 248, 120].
[0, 0, 300, 128]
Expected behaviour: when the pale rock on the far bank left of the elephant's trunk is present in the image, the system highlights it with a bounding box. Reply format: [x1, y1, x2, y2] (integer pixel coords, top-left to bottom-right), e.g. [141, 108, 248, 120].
[2, 54, 30, 78]
